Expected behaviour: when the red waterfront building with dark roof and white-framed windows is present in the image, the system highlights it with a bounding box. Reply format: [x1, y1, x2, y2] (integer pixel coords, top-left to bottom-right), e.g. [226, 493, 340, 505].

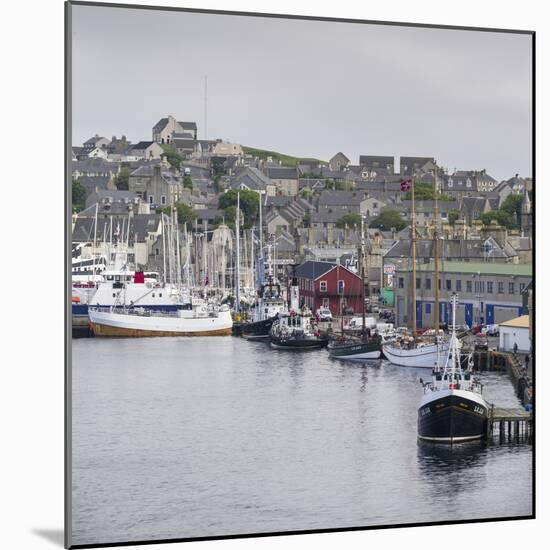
[296, 261, 362, 315]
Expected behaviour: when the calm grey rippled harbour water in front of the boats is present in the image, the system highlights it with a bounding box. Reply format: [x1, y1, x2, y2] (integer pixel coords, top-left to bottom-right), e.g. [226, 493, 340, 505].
[72, 337, 532, 544]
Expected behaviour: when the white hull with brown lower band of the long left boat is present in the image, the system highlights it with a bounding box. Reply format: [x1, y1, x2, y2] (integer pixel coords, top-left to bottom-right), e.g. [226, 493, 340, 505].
[89, 309, 233, 337]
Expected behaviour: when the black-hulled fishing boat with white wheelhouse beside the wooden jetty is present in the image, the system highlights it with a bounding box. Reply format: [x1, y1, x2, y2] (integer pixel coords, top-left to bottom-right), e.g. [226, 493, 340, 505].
[418, 295, 489, 444]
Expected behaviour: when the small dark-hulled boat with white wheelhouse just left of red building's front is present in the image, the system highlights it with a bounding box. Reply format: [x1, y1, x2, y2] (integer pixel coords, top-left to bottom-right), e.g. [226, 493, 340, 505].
[270, 273, 328, 350]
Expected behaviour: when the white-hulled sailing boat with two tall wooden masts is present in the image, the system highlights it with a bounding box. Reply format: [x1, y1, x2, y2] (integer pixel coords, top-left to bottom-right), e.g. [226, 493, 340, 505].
[382, 172, 449, 368]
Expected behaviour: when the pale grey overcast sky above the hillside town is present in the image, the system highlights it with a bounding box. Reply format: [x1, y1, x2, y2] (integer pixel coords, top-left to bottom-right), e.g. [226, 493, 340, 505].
[72, 6, 532, 180]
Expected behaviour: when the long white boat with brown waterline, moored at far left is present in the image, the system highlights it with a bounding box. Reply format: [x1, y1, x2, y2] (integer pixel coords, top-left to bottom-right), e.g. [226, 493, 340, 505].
[88, 304, 233, 337]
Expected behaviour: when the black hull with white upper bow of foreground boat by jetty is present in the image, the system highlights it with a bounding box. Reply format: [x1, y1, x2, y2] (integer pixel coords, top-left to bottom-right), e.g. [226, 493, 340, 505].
[418, 390, 488, 444]
